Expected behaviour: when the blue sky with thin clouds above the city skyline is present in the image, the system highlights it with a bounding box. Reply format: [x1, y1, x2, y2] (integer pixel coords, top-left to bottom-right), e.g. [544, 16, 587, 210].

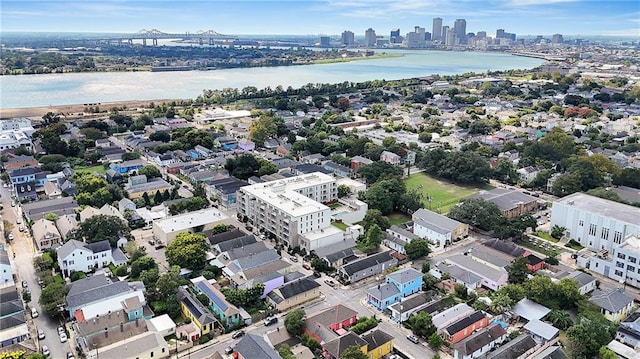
[0, 0, 640, 38]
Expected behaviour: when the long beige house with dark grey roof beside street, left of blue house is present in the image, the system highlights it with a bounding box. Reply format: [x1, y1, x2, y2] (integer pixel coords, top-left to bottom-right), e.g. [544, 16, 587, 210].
[267, 277, 320, 312]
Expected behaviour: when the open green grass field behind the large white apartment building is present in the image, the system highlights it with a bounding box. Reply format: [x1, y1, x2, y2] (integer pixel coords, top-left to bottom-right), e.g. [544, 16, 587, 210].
[405, 172, 493, 213]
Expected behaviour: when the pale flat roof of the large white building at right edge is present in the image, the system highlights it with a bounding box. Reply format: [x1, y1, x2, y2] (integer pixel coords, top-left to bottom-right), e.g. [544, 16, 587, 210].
[556, 192, 640, 225]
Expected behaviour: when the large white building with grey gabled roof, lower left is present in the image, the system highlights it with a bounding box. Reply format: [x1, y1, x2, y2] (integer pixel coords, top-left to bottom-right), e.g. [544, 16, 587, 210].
[66, 274, 147, 322]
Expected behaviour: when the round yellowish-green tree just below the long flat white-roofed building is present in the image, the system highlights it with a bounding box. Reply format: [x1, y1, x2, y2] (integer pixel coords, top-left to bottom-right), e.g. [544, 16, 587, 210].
[165, 233, 209, 270]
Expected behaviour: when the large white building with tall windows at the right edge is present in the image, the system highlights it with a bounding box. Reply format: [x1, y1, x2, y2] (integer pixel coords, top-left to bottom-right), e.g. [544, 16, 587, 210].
[551, 193, 640, 252]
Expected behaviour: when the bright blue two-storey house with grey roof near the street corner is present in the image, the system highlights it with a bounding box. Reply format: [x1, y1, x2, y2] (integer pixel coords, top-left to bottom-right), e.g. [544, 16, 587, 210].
[367, 268, 422, 311]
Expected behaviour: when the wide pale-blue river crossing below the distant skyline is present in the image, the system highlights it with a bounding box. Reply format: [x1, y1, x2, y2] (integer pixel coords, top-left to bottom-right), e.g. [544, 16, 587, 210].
[0, 50, 544, 108]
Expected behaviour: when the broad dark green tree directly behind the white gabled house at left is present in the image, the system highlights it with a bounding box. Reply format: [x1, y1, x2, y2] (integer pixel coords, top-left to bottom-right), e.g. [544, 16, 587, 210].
[76, 214, 131, 247]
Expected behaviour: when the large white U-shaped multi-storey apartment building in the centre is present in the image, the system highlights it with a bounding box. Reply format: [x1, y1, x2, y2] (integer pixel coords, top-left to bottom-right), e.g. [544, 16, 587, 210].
[236, 172, 342, 250]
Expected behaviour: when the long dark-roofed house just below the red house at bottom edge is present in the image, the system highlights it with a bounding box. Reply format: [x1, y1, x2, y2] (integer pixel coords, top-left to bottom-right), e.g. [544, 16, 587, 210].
[453, 324, 507, 359]
